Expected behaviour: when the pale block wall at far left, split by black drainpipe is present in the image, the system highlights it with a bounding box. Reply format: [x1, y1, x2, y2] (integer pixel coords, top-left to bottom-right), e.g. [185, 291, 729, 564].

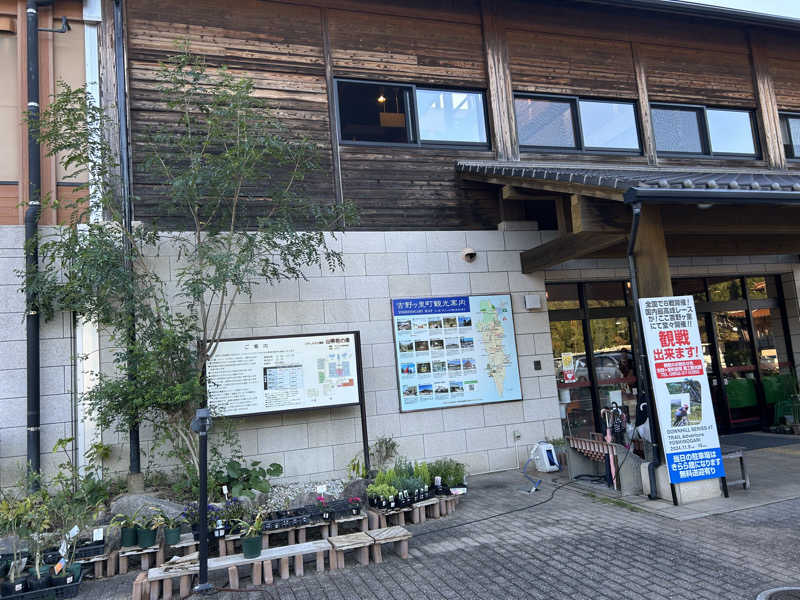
[0, 225, 73, 487]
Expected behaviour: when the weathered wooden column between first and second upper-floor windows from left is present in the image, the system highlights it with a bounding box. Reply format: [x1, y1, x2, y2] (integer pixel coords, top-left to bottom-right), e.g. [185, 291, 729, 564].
[481, 0, 519, 160]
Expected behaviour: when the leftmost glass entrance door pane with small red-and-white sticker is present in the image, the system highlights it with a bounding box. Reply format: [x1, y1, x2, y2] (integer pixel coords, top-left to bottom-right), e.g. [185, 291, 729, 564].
[550, 320, 595, 437]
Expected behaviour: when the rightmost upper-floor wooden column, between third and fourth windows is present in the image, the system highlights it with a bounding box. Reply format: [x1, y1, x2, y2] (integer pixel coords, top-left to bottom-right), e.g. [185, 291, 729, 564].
[748, 31, 786, 169]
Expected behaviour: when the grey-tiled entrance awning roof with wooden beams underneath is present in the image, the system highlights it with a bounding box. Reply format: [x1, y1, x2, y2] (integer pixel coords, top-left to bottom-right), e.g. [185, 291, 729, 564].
[456, 161, 800, 273]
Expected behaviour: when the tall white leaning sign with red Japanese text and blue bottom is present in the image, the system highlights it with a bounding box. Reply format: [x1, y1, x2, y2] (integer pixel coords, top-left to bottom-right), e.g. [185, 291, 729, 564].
[639, 296, 725, 483]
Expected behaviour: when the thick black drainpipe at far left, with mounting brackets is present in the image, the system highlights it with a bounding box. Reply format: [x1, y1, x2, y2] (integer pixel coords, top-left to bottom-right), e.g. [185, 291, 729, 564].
[25, 0, 42, 485]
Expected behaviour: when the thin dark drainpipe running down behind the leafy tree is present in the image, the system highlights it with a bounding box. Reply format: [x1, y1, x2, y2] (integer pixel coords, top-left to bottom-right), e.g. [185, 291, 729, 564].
[114, 0, 141, 480]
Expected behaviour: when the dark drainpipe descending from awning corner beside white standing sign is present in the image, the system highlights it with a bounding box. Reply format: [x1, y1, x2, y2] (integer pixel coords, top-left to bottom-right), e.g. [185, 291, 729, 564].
[628, 202, 661, 500]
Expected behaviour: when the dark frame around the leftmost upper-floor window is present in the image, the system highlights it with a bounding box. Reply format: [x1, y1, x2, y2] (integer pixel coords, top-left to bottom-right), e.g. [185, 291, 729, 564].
[333, 77, 492, 150]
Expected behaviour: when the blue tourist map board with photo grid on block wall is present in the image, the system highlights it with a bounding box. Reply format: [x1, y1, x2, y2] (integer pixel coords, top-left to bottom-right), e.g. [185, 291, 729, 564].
[392, 295, 522, 411]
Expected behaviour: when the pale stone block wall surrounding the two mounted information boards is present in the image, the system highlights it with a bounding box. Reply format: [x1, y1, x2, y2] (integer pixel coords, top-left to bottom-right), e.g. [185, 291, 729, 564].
[101, 223, 561, 480]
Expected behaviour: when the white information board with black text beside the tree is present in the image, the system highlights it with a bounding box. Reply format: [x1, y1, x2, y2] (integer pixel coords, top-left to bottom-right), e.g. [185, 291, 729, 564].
[206, 332, 361, 416]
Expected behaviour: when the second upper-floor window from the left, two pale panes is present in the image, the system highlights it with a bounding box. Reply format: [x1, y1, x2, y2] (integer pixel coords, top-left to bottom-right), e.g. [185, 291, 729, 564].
[514, 95, 640, 153]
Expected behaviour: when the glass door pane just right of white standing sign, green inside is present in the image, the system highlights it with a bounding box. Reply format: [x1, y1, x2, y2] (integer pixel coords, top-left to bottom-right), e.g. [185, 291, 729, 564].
[714, 310, 761, 427]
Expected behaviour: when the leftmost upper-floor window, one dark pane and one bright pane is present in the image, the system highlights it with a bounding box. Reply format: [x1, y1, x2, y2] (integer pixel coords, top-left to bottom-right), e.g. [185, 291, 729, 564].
[336, 80, 488, 146]
